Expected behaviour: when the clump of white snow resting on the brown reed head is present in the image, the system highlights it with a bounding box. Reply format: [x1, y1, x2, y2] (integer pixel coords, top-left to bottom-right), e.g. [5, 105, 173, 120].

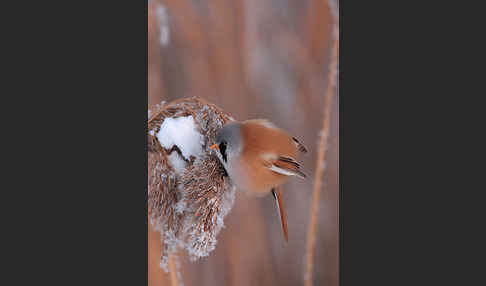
[157, 115, 204, 160]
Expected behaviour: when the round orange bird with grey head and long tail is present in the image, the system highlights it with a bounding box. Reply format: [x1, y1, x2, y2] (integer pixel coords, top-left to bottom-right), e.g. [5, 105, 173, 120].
[210, 119, 307, 242]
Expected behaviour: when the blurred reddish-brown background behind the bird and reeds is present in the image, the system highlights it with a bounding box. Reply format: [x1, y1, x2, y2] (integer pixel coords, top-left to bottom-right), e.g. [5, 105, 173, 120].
[148, 0, 339, 286]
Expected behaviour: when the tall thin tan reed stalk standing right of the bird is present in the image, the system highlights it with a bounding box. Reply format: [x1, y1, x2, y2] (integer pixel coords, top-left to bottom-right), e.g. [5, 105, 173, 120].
[304, 26, 339, 286]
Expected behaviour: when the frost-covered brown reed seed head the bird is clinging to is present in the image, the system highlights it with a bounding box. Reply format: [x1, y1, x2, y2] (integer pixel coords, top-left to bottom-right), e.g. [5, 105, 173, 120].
[147, 97, 235, 271]
